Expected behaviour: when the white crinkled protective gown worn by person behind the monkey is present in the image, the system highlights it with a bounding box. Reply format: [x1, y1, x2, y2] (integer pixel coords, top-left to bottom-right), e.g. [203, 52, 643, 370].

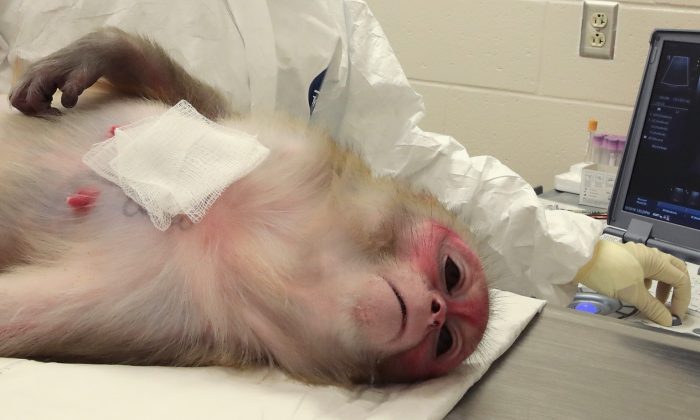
[0, 0, 603, 305]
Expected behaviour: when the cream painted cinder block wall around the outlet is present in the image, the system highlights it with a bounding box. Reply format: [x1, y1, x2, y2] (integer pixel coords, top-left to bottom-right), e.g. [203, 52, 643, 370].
[368, 0, 700, 189]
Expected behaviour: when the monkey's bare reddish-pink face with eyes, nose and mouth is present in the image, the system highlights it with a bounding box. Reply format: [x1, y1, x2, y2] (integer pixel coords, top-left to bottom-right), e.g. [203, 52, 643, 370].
[354, 221, 489, 382]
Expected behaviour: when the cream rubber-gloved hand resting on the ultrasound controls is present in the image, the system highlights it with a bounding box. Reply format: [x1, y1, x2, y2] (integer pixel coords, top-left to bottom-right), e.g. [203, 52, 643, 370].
[574, 241, 690, 327]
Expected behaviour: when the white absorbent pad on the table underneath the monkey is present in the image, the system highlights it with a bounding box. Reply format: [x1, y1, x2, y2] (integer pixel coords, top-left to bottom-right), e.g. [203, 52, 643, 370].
[0, 291, 545, 420]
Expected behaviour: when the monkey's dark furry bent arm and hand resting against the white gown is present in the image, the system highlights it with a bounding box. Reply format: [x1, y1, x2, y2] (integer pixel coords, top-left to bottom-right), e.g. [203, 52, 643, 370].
[10, 28, 231, 119]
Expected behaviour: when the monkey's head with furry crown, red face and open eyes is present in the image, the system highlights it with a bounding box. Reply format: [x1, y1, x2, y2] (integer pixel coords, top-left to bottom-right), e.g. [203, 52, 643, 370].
[274, 170, 489, 383]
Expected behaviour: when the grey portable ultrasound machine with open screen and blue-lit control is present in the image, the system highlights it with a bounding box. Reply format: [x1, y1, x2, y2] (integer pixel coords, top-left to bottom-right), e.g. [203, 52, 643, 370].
[571, 30, 700, 338]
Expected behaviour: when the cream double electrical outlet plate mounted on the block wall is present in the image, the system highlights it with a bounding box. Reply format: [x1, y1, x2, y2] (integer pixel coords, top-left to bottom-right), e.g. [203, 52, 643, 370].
[579, 1, 618, 60]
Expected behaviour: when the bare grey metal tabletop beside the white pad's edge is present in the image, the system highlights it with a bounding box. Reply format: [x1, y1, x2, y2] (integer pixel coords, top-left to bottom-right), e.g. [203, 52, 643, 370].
[447, 306, 700, 420]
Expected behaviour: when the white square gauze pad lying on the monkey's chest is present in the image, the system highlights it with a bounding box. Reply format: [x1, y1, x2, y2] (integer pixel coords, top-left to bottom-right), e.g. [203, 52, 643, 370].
[83, 101, 270, 231]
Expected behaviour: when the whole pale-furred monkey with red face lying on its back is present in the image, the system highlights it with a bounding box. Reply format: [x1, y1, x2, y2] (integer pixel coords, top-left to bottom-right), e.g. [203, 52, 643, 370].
[0, 29, 489, 384]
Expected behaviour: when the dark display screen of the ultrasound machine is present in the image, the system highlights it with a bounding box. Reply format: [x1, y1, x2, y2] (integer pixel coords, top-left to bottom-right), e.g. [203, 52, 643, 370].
[624, 41, 700, 229]
